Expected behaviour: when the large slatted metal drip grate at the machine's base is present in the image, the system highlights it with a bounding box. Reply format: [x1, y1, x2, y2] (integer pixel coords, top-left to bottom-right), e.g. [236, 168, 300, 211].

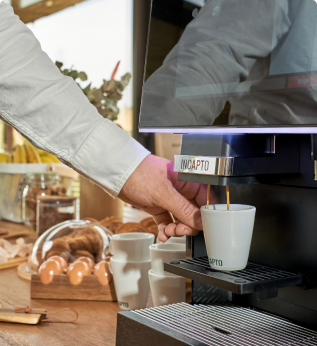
[130, 303, 317, 346]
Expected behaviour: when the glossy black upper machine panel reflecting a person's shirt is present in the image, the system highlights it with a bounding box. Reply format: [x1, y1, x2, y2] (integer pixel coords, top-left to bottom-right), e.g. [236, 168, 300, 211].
[140, 0, 317, 133]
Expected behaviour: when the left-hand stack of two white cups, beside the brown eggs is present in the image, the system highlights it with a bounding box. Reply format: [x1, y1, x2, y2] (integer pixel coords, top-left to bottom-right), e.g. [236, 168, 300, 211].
[110, 233, 154, 310]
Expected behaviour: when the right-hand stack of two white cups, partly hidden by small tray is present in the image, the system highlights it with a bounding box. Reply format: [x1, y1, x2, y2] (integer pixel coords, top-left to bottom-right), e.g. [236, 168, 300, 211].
[149, 243, 186, 306]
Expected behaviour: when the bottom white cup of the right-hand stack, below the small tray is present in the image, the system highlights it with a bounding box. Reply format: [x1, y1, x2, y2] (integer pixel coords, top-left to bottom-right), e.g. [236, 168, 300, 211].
[149, 269, 186, 306]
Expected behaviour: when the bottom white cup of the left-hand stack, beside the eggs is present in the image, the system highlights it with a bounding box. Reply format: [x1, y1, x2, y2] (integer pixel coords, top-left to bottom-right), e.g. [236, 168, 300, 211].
[110, 257, 151, 310]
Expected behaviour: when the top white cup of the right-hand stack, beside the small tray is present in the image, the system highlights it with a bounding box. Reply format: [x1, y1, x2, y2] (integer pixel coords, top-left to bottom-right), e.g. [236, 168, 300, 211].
[150, 243, 186, 276]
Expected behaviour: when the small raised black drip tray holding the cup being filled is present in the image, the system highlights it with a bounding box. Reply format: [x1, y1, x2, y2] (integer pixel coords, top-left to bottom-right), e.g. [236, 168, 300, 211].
[164, 257, 304, 299]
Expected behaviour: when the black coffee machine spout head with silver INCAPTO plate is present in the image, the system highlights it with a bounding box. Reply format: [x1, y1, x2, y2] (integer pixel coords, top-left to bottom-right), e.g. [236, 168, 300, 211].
[174, 134, 300, 186]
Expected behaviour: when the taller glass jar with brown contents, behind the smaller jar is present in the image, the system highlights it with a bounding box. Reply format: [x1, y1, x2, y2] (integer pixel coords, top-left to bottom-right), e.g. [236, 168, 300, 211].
[22, 173, 74, 231]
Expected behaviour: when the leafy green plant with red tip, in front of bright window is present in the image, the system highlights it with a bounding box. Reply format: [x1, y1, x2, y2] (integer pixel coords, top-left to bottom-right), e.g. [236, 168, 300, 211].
[55, 61, 131, 121]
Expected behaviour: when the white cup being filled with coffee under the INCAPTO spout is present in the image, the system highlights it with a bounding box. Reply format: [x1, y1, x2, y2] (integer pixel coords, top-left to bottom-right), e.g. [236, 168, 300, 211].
[201, 204, 255, 271]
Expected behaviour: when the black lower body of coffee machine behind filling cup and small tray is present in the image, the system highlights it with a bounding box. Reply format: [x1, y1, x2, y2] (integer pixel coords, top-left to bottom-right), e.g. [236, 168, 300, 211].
[193, 180, 317, 330]
